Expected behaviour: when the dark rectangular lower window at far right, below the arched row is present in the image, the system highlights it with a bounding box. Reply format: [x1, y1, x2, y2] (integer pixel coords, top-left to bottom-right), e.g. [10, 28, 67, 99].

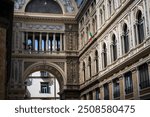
[138, 63, 150, 89]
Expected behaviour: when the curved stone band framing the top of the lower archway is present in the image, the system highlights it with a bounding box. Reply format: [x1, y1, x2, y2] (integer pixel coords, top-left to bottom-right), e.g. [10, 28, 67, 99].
[23, 62, 65, 89]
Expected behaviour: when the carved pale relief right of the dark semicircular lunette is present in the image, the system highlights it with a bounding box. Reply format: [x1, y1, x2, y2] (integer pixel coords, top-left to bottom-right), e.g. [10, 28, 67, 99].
[61, 0, 74, 13]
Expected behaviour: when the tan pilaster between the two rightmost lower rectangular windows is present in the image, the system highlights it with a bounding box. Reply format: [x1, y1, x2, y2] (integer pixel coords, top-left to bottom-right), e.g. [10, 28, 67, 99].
[132, 68, 139, 100]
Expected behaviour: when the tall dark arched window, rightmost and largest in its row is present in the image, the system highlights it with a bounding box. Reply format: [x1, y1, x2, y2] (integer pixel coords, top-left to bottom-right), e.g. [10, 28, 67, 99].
[137, 11, 144, 44]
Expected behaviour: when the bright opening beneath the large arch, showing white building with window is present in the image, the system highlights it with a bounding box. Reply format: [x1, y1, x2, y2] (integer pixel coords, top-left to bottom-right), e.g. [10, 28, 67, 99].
[25, 71, 60, 100]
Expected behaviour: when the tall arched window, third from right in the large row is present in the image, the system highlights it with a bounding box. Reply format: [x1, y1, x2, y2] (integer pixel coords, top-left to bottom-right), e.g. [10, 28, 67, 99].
[110, 34, 117, 61]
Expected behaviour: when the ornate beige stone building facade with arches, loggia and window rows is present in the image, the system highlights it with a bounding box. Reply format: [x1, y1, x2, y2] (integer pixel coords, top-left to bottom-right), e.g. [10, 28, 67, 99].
[6, 0, 150, 100]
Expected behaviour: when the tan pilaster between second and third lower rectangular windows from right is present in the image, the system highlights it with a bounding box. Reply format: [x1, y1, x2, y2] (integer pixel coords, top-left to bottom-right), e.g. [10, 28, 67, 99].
[119, 75, 125, 100]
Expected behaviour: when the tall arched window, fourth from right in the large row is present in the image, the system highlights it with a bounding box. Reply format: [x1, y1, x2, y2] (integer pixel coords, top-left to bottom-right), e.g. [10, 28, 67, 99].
[102, 43, 107, 68]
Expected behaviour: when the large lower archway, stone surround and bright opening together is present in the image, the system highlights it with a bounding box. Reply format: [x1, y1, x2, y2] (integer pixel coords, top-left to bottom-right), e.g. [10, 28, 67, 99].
[23, 63, 64, 100]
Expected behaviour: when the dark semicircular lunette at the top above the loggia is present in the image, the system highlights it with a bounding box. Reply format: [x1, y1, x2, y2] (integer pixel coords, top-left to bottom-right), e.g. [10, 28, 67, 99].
[25, 0, 63, 14]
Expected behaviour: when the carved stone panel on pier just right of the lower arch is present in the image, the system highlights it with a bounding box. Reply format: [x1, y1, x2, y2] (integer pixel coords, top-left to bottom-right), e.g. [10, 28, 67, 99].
[67, 59, 79, 84]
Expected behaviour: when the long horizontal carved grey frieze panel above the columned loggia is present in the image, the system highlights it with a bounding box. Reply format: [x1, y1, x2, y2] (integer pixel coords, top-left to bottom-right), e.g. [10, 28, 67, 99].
[14, 22, 65, 31]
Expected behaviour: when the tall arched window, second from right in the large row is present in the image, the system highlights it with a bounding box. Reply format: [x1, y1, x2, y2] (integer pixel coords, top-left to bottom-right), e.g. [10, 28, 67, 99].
[122, 24, 129, 53]
